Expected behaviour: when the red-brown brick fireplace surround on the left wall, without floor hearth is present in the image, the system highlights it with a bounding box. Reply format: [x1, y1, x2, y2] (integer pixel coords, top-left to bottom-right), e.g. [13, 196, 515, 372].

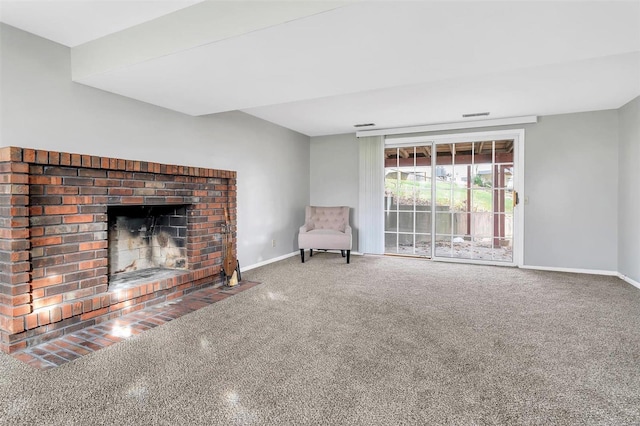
[0, 147, 236, 353]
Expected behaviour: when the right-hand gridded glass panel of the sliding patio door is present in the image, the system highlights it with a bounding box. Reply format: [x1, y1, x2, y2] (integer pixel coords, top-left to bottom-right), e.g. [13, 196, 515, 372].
[416, 140, 514, 261]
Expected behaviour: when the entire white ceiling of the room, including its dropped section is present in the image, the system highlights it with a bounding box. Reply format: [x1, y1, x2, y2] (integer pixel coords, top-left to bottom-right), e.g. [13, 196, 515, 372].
[0, 0, 640, 136]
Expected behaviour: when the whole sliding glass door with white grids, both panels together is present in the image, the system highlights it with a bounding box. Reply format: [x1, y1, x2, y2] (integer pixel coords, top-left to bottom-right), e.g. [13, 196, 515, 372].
[384, 139, 515, 264]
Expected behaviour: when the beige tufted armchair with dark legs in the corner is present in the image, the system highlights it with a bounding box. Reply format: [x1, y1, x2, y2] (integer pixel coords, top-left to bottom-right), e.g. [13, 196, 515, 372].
[298, 206, 351, 263]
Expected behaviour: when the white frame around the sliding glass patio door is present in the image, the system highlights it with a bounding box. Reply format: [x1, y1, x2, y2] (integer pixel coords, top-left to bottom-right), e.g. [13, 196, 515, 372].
[385, 129, 526, 267]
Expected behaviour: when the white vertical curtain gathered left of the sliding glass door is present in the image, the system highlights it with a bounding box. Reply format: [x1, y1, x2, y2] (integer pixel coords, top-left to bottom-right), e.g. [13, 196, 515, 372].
[358, 136, 384, 254]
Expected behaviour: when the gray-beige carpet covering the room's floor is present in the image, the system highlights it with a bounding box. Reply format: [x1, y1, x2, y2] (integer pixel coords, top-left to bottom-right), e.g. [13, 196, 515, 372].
[0, 253, 640, 425]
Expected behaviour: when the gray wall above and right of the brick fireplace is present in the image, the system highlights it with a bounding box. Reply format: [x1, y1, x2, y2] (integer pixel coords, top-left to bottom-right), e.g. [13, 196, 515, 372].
[0, 24, 310, 267]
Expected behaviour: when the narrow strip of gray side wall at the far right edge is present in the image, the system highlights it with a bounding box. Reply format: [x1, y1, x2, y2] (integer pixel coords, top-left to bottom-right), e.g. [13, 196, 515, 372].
[618, 97, 640, 282]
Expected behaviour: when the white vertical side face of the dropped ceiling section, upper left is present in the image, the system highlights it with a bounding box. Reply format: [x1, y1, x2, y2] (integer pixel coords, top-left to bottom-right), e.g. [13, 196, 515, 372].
[71, 0, 353, 83]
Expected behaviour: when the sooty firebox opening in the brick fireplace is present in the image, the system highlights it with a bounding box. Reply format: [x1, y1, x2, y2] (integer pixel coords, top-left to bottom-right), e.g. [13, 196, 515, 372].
[107, 205, 187, 290]
